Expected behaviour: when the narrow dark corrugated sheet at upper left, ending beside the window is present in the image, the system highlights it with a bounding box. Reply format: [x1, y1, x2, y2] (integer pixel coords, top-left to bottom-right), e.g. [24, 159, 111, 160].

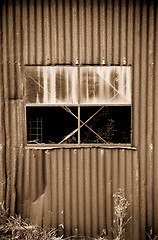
[1, 1, 23, 99]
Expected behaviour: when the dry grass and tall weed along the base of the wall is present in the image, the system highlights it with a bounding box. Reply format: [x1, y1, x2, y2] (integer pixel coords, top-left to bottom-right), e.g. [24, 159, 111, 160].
[0, 189, 131, 240]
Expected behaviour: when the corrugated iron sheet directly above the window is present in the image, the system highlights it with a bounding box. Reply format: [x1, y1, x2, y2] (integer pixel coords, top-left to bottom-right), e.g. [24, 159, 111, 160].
[22, 0, 134, 65]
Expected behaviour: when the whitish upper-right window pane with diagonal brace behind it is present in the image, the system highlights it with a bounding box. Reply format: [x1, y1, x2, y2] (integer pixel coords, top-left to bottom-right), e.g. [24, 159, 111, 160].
[80, 66, 131, 105]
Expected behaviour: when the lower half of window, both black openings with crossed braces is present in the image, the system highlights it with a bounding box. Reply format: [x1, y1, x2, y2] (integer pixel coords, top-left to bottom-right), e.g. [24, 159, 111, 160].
[26, 106, 131, 144]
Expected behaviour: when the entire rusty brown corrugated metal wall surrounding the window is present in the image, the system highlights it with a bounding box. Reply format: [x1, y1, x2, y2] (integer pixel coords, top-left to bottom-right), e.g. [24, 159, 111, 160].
[0, 0, 158, 239]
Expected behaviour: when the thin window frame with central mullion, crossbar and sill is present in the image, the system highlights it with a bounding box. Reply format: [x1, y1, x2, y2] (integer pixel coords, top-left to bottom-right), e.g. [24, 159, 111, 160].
[24, 65, 135, 149]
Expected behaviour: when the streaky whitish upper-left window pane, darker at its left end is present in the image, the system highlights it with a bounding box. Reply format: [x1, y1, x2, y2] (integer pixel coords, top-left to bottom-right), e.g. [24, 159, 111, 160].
[25, 66, 78, 104]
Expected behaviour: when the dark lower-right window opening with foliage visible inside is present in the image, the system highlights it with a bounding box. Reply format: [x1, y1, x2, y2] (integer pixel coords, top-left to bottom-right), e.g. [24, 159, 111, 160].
[80, 106, 131, 144]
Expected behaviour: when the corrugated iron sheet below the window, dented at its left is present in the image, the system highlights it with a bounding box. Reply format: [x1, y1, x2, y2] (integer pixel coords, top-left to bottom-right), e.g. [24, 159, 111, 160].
[14, 148, 139, 239]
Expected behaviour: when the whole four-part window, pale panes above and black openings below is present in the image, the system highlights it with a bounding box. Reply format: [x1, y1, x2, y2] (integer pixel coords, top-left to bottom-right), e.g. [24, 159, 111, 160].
[25, 66, 131, 144]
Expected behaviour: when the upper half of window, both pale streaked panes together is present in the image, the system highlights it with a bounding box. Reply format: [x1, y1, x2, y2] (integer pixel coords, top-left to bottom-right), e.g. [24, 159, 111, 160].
[25, 66, 131, 105]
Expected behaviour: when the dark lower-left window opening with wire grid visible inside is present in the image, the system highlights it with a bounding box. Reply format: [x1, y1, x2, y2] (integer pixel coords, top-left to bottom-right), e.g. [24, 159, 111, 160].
[26, 107, 78, 144]
